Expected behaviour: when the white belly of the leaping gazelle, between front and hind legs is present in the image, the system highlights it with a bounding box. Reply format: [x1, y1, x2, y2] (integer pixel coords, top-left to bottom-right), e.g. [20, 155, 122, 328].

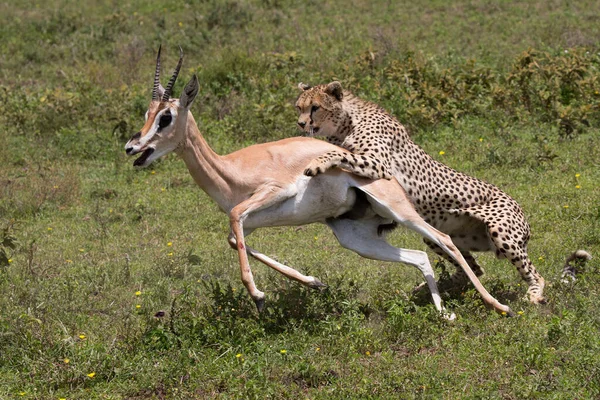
[244, 173, 356, 229]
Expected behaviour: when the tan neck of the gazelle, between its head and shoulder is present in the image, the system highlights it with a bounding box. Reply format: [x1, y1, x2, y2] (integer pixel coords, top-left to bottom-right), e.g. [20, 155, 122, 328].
[177, 112, 240, 212]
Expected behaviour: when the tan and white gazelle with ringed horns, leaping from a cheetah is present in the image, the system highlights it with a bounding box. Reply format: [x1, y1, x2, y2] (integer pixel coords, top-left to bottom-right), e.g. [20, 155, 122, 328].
[125, 48, 510, 318]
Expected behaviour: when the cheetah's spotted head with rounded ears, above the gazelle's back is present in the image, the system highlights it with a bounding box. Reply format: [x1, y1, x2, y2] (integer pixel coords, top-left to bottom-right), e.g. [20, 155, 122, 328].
[296, 81, 344, 136]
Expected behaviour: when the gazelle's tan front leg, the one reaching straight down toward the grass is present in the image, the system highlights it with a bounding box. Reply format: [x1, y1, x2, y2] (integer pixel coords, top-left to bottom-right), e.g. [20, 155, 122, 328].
[229, 186, 295, 312]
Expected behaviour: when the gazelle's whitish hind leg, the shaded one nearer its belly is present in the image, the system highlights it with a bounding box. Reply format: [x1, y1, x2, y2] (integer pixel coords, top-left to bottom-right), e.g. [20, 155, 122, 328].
[327, 218, 455, 319]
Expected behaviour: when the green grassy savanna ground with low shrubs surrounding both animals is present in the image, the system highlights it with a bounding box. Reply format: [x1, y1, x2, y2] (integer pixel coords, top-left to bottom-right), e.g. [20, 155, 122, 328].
[0, 0, 600, 399]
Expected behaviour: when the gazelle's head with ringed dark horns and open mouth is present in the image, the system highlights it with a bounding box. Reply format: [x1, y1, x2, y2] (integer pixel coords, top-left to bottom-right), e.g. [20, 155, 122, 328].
[125, 47, 198, 167]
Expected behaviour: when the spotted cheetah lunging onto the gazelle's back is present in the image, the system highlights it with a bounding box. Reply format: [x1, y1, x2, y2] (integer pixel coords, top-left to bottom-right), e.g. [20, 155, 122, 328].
[296, 81, 564, 304]
